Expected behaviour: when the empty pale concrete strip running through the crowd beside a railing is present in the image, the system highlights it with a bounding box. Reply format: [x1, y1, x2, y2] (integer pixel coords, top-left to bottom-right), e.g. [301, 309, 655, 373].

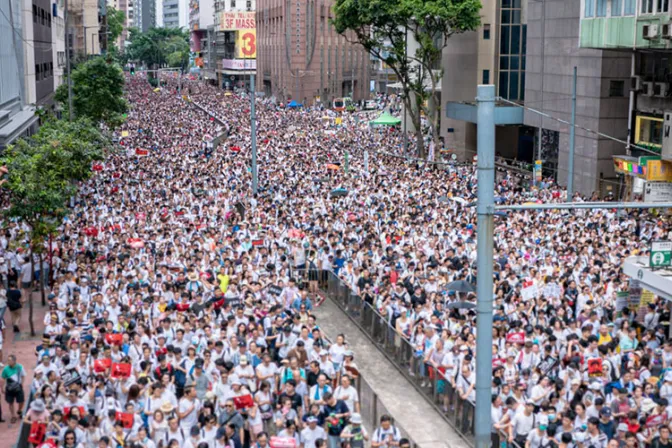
[313, 299, 469, 448]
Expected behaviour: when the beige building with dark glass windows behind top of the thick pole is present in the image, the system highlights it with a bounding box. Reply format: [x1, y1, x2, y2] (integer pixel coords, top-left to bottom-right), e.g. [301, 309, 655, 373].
[440, 0, 534, 163]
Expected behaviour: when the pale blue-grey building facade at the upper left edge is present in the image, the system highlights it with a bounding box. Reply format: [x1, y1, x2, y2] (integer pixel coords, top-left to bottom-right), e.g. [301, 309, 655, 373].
[0, 0, 38, 149]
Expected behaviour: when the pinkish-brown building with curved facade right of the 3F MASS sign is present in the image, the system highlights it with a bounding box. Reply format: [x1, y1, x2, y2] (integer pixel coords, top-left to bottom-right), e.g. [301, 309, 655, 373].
[256, 0, 370, 104]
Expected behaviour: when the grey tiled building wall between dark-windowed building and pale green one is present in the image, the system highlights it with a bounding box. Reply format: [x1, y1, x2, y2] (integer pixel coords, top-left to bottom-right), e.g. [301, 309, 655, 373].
[525, 0, 630, 194]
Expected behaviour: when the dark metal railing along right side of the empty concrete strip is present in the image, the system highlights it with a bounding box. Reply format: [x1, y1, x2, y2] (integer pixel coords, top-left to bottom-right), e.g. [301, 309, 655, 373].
[293, 270, 521, 448]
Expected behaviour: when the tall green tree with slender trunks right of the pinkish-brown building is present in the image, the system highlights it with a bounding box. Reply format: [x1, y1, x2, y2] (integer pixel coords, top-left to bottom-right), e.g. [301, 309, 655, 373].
[332, 0, 481, 157]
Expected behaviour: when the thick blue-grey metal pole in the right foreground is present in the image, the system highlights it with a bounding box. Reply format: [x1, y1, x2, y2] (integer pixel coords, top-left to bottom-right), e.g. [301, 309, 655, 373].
[474, 85, 495, 448]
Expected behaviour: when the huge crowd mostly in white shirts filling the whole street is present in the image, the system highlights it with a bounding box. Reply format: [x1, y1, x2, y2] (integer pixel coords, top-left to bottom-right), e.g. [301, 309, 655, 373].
[0, 73, 672, 448]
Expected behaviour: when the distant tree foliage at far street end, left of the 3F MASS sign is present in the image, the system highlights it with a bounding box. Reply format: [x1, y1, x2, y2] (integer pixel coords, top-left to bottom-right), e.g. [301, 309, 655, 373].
[126, 28, 189, 68]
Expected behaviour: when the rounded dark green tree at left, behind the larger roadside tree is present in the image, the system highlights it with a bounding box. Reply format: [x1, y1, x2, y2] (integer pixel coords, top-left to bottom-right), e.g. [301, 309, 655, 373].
[55, 57, 128, 127]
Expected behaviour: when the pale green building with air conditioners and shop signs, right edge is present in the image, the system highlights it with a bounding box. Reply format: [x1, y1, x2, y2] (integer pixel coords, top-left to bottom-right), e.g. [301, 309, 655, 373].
[579, 0, 672, 196]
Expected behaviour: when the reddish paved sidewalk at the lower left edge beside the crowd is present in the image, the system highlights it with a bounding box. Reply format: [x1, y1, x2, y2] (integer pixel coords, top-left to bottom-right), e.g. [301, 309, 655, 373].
[0, 292, 47, 448]
